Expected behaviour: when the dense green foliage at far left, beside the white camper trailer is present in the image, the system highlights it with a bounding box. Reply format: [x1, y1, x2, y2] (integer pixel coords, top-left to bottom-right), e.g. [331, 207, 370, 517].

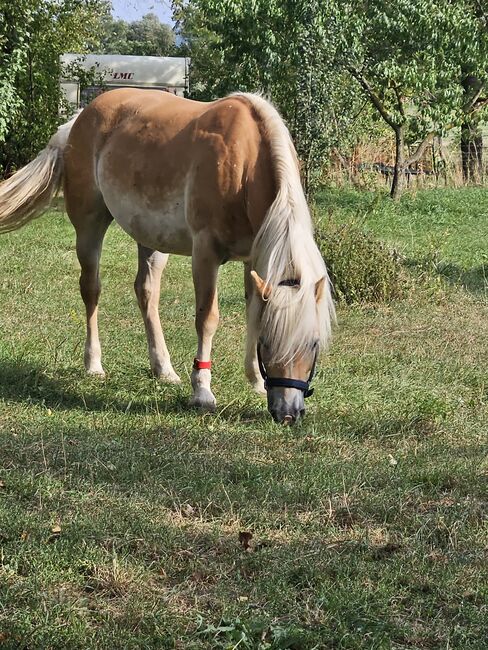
[0, 0, 108, 175]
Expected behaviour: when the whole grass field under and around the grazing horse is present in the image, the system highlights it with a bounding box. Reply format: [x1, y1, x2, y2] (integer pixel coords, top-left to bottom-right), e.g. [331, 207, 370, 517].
[0, 189, 488, 650]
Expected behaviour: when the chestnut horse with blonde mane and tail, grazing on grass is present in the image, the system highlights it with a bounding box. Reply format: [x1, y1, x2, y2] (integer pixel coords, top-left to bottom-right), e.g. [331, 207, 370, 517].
[0, 89, 334, 423]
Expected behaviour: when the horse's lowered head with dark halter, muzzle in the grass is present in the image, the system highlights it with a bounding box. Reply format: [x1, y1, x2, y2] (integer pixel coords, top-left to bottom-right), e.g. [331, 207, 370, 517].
[251, 271, 332, 424]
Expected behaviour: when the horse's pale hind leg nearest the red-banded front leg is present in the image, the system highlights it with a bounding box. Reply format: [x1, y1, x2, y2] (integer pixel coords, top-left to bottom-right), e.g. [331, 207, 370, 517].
[134, 244, 180, 383]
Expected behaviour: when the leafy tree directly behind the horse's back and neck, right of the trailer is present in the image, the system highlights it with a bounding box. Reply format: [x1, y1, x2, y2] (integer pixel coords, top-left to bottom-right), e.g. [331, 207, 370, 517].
[173, 0, 354, 194]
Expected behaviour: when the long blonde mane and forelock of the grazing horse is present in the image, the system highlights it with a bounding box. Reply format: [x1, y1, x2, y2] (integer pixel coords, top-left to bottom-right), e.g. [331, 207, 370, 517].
[238, 93, 335, 362]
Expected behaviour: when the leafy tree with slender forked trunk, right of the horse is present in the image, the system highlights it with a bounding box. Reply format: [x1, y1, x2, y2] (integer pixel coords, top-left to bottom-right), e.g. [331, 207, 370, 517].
[342, 0, 486, 199]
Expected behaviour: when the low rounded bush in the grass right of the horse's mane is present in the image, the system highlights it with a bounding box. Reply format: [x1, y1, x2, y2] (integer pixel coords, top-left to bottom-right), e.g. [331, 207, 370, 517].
[315, 213, 409, 304]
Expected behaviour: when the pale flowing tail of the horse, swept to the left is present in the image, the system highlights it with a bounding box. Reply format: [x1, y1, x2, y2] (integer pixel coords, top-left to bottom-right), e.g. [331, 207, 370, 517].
[0, 111, 80, 233]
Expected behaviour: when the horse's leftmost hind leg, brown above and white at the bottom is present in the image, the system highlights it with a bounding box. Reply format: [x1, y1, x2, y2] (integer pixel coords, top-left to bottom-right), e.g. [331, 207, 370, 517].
[72, 209, 112, 377]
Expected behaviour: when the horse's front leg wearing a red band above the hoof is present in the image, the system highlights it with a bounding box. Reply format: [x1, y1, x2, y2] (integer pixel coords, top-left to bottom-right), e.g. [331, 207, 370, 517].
[190, 233, 222, 411]
